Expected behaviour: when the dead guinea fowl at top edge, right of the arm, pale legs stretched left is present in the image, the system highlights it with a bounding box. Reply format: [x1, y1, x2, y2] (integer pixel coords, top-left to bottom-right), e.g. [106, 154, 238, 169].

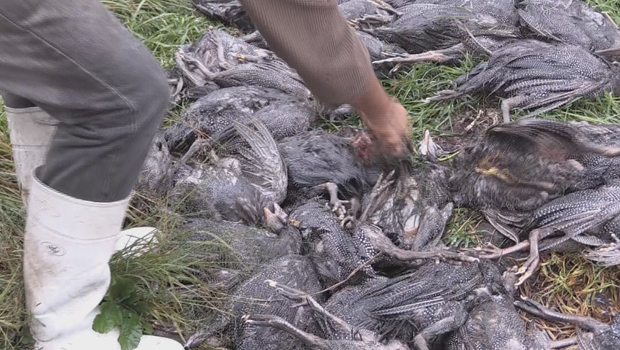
[359, 0, 519, 66]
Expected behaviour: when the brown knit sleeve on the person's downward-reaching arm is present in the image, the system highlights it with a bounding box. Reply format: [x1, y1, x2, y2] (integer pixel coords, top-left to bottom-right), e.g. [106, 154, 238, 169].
[240, 0, 376, 105]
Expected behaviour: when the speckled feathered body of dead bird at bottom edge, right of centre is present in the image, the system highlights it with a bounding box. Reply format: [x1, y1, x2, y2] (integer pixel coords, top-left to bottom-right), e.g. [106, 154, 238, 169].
[326, 262, 507, 349]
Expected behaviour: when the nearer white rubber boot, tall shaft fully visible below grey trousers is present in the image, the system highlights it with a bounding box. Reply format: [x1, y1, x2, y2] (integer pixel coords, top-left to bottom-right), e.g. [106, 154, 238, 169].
[24, 170, 183, 350]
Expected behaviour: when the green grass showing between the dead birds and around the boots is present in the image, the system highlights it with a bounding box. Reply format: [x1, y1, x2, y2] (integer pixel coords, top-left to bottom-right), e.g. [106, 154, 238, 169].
[0, 0, 620, 350]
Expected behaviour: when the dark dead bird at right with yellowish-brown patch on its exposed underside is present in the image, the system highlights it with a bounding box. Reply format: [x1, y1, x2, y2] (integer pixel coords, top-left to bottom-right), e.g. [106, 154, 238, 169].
[449, 119, 620, 242]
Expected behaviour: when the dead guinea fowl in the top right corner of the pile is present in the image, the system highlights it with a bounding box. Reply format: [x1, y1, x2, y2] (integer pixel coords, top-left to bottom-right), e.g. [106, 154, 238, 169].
[517, 0, 620, 52]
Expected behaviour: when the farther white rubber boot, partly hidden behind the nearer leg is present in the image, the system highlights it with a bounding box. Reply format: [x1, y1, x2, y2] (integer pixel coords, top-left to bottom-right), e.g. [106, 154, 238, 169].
[4, 106, 156, 256]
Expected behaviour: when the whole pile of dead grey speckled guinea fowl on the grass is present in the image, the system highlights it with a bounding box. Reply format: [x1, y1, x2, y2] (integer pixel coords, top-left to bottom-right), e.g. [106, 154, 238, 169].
[137, 0, 620, 350]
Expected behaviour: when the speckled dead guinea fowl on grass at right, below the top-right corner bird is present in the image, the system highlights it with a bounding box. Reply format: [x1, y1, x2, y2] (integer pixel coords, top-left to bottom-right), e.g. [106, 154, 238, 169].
[426, 39, 620, 123]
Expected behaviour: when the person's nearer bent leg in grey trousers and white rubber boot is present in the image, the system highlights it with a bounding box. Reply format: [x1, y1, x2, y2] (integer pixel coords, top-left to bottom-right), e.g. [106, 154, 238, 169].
[0, 0, 183, 350]
